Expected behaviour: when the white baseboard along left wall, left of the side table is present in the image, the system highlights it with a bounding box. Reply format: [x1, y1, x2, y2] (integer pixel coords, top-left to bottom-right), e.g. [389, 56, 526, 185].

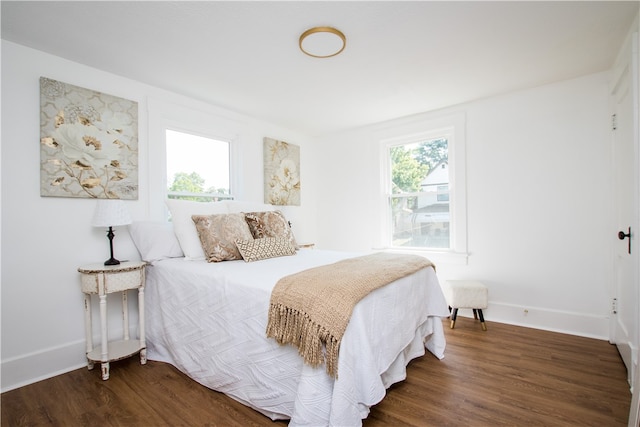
[0, 340, 87, 393]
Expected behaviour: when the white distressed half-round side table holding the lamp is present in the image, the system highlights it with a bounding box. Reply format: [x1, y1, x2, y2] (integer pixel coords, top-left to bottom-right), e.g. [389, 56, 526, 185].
[78, 261, 147, 380]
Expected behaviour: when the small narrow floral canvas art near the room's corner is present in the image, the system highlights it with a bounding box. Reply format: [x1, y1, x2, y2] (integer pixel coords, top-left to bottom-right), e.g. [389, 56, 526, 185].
[264, 138, 300, 206]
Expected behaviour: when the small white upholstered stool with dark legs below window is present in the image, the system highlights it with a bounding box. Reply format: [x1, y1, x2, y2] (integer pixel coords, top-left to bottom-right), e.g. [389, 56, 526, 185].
[442, 280, 489, 331]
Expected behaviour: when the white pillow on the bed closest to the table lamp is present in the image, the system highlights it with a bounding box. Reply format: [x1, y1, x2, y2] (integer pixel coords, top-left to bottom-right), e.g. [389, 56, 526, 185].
[129, 221, 184, 264]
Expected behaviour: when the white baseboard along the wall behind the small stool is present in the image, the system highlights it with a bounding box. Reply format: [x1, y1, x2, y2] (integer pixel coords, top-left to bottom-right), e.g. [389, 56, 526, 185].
[458, 301, 609, 340]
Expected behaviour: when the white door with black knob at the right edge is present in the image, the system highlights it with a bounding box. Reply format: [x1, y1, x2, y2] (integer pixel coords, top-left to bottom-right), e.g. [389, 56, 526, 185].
[610, 34, 640, 425]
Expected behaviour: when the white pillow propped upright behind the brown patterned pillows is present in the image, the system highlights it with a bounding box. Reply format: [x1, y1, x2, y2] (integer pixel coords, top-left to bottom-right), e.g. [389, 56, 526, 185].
[166, 199, 228, 260]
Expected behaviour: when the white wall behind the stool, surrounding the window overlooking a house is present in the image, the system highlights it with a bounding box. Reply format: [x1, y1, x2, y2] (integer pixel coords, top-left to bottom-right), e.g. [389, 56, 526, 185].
[315, 73, 616, 339]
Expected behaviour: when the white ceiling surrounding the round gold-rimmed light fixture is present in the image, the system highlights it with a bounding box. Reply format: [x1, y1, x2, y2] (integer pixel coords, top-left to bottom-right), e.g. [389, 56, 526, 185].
[1, 1, 640, 135]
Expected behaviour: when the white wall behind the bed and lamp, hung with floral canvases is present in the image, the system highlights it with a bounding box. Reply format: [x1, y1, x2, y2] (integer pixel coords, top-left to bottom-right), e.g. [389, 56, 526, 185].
[0, 41, 317, 391]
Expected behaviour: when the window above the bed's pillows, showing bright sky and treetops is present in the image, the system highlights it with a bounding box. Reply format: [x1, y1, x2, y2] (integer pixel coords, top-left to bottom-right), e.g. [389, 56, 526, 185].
[166, 129, 233, 201]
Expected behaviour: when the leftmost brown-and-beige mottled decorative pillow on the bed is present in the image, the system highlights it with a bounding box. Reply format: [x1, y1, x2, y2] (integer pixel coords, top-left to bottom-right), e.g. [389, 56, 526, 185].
[192, 213, 252, 262]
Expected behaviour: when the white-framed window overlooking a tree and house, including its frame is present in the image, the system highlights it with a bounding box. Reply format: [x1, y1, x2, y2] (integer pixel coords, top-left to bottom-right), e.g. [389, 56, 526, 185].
[381, 115, 467, 262]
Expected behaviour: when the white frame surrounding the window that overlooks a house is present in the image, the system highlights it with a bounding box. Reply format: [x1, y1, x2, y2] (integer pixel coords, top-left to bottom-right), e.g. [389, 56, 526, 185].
[376, 113, 468, 264]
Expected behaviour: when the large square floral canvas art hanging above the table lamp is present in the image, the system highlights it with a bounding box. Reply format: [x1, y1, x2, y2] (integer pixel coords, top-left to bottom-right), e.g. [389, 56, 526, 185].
[40, 77, 138, 200]
